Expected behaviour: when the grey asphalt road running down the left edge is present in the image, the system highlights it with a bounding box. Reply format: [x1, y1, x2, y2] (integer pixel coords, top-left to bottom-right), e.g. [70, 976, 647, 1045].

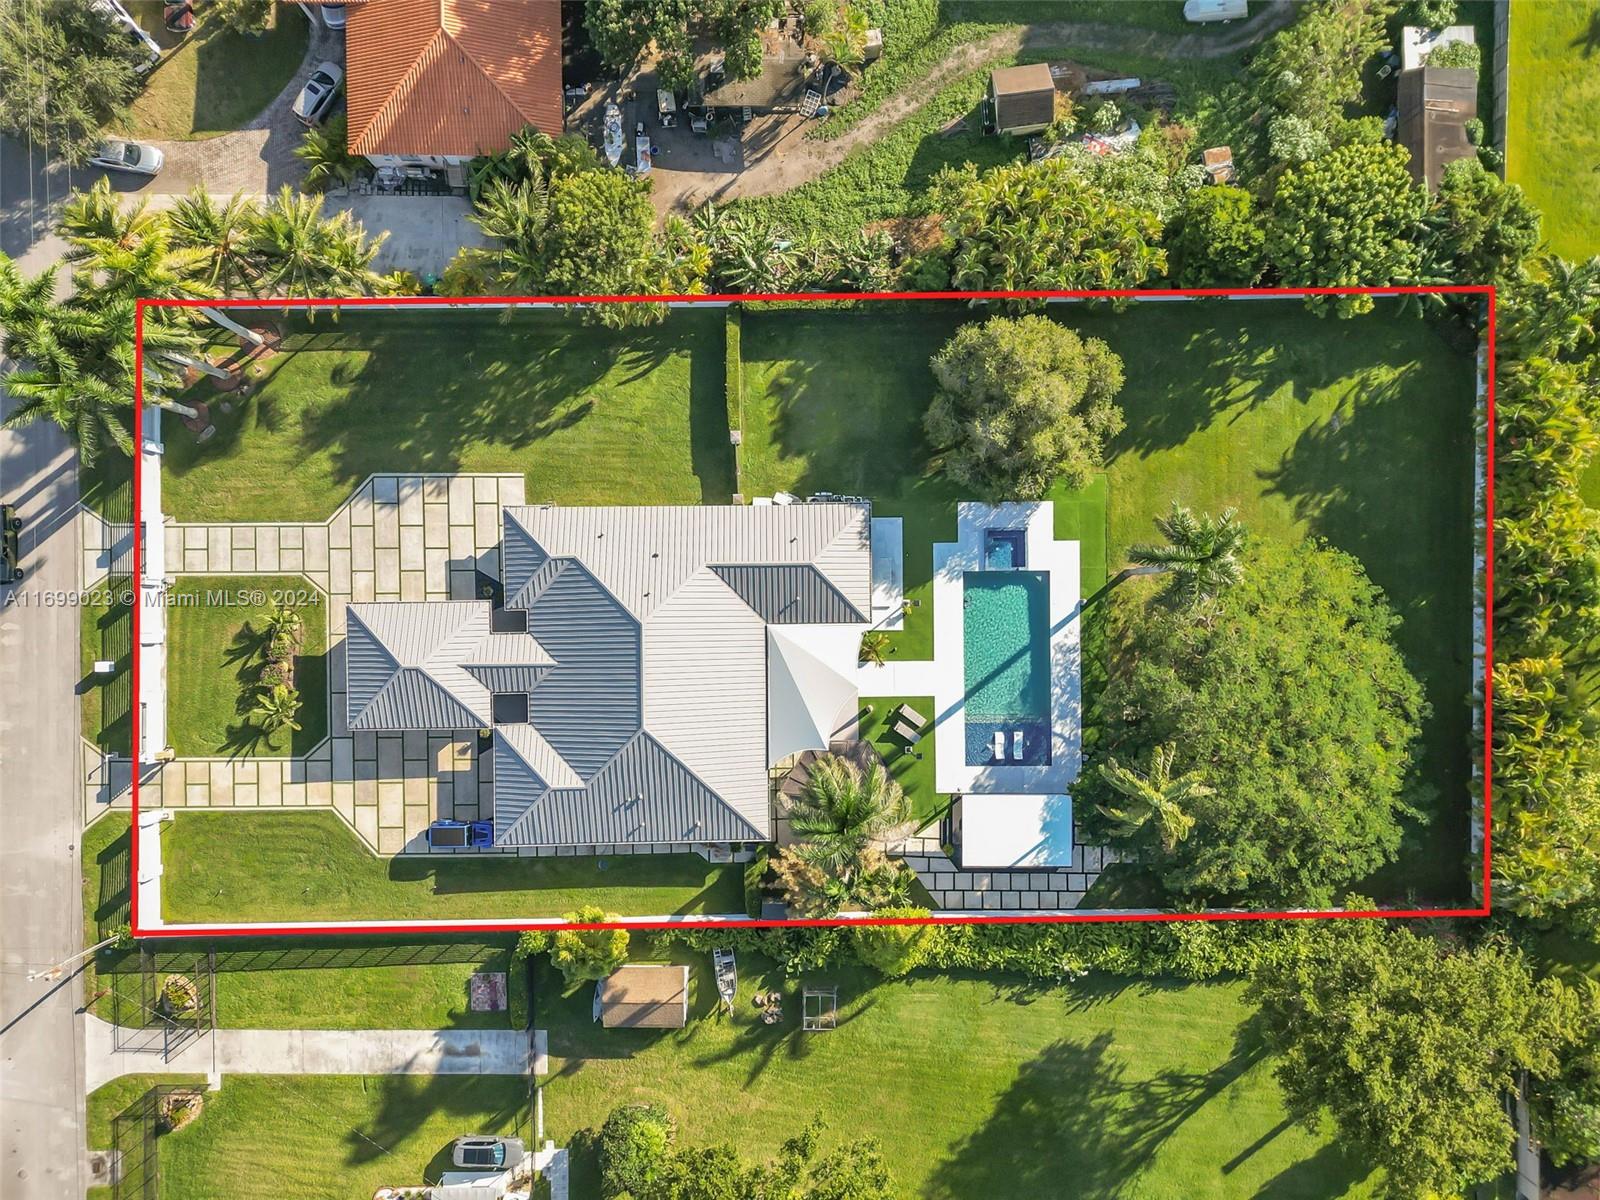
[0, 142, 86, 1200]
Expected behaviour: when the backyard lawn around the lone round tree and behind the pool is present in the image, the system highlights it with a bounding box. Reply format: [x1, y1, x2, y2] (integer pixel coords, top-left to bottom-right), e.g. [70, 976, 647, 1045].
[742, 301, 1474, 899]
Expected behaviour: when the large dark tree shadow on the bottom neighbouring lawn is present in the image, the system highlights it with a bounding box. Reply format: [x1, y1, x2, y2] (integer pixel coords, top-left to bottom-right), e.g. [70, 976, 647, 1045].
[925, 1022, 1266, 1200]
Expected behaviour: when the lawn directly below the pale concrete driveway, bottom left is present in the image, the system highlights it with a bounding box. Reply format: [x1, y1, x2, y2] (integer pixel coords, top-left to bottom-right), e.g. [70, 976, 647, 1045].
[90, 1075, 533, 1200]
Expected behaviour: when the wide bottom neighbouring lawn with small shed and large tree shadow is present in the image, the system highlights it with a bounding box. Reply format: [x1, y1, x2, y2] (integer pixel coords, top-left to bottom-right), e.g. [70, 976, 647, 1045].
[534, 939, 1376, 1200]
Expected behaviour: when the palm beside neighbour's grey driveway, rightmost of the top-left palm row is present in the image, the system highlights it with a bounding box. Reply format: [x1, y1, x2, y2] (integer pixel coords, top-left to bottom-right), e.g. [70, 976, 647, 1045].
[250, 184, 386, 296]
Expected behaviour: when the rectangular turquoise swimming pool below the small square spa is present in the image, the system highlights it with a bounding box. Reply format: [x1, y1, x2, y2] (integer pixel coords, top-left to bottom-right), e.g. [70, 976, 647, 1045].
[962, 571, 1050, 766]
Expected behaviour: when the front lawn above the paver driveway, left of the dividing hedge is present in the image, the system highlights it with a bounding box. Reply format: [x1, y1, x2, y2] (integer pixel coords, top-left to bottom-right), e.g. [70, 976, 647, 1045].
[162, 309, 733, 522]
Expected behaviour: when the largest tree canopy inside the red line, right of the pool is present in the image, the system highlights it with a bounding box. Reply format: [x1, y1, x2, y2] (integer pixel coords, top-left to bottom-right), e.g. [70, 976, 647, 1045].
[1075, 542, 1426, 906]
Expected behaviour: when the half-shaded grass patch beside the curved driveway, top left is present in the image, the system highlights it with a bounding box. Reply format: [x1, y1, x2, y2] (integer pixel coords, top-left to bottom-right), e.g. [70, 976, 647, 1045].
[126, 0, 312, 141]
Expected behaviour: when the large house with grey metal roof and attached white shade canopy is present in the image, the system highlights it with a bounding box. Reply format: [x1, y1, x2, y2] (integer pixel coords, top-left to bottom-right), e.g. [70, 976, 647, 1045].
[342, 502, 872, 848]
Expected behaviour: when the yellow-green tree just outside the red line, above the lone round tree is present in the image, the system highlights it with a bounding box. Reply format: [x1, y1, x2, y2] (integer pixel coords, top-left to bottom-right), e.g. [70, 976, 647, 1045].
[931, 158, 1166, 291]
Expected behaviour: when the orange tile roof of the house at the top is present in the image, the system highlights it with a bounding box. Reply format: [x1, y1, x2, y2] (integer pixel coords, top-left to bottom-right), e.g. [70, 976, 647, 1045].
[344, 0, 562, 165]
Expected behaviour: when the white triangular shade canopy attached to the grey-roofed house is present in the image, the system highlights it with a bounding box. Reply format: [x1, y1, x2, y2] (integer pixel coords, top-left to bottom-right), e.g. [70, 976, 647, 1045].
[766, 624, 861, 763]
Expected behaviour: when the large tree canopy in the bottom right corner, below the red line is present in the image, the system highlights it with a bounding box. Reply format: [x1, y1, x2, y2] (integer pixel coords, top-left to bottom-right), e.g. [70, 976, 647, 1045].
[1250, 922, 1579, 1200]
